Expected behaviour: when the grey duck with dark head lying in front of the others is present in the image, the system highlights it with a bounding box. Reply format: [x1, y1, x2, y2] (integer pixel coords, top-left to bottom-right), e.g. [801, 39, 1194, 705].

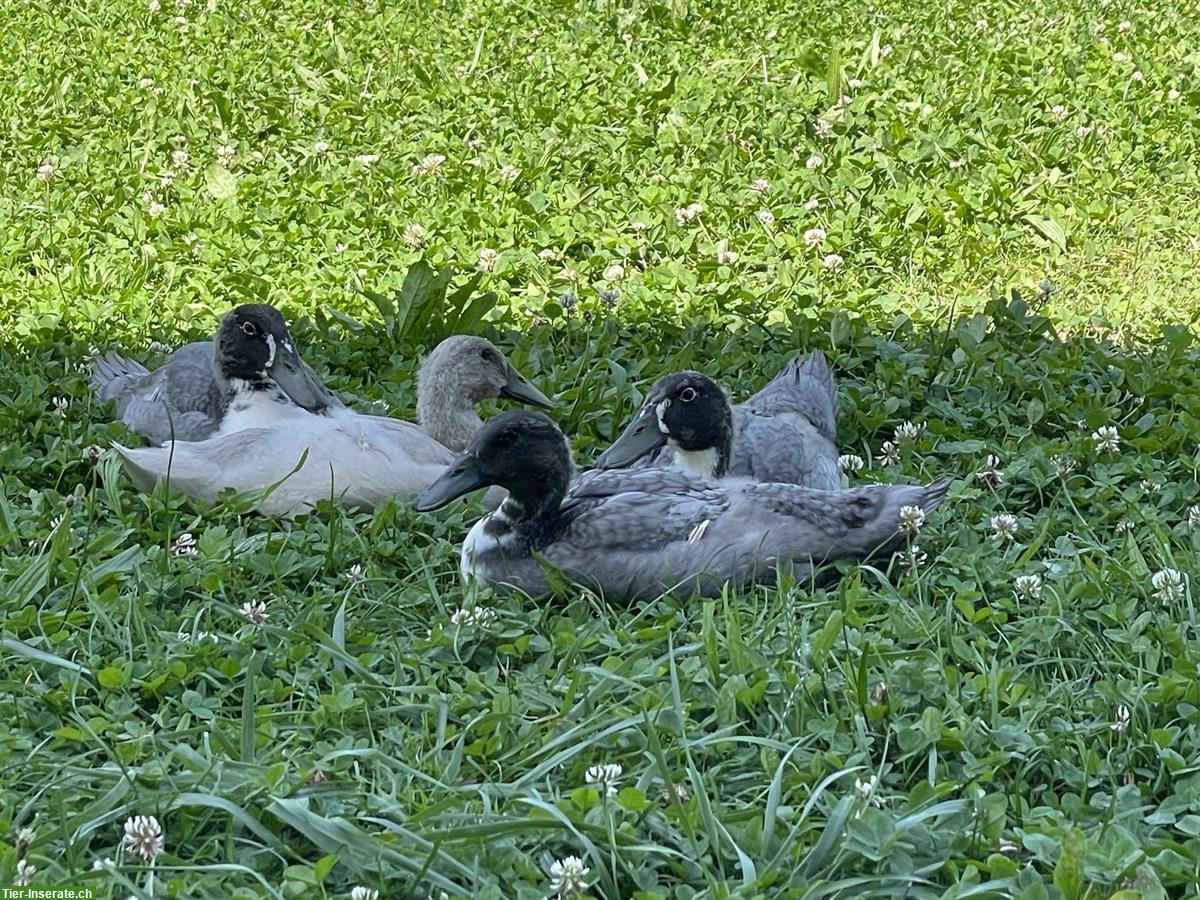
[413, 410, 952, 602]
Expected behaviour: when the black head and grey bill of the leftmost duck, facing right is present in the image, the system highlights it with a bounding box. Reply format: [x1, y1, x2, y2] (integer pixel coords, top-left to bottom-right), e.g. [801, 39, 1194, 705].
[215, 304, 334, 412]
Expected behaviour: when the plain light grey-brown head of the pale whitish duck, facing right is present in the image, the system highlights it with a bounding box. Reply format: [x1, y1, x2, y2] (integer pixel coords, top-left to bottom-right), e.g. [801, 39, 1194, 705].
[420, 335, 554, 409]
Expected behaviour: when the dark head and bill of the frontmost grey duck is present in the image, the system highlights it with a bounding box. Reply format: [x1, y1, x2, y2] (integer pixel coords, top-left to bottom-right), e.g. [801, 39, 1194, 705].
[413, 409, 571, 516]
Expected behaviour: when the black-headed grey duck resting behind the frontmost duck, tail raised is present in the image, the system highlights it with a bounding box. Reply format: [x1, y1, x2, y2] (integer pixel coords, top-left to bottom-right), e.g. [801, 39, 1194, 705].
[596, 350, 841, 491]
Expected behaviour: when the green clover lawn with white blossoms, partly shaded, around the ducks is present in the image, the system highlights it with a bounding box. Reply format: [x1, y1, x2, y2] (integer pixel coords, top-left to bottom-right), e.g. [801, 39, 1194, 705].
[0, 0, 1200, 900]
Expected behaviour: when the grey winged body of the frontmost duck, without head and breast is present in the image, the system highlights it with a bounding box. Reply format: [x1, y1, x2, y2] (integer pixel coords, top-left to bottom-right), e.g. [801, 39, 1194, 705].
[541, 469, 950, 600]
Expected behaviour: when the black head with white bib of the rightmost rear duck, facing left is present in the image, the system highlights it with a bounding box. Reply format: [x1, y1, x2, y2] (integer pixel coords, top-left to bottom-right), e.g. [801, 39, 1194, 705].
[596, 372, 733, 478]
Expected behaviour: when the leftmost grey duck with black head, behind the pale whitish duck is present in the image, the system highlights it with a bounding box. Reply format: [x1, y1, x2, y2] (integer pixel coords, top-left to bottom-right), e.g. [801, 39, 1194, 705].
[91, 304, 344, 444]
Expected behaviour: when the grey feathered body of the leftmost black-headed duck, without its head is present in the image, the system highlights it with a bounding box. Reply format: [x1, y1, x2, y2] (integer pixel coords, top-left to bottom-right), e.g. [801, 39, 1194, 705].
[91, 341, 226, 444]
